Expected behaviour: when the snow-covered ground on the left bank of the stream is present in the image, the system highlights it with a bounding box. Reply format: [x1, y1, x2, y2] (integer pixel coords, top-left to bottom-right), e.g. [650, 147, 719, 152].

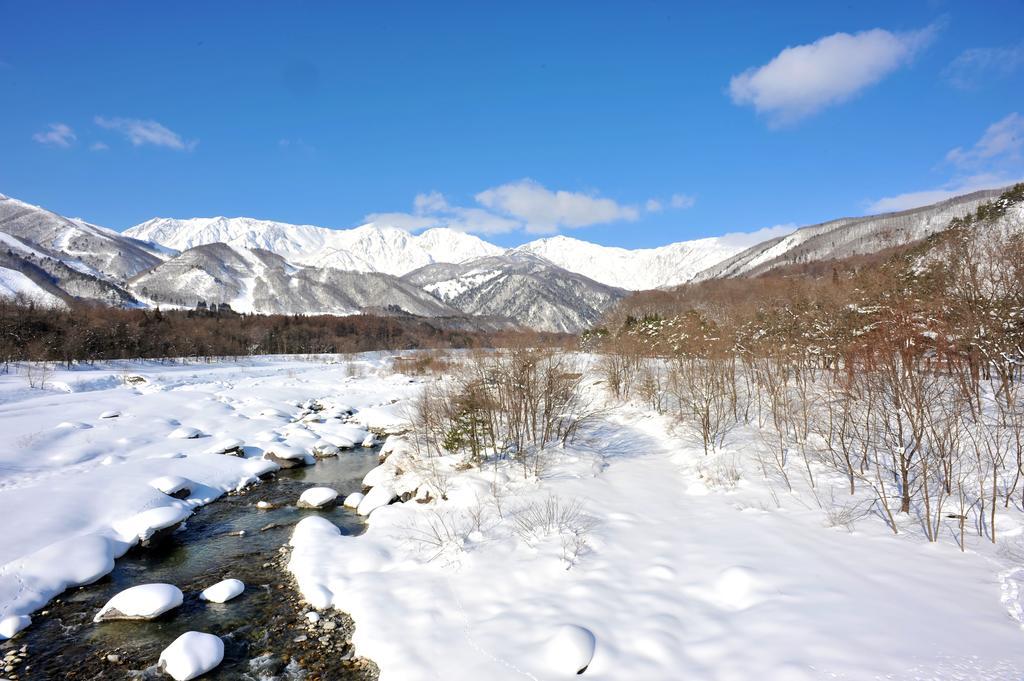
[0, 354, 419, 620]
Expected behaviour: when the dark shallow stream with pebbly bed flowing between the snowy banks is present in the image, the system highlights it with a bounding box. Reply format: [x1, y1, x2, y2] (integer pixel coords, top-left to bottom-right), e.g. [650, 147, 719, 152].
[0, 449, 378, 680]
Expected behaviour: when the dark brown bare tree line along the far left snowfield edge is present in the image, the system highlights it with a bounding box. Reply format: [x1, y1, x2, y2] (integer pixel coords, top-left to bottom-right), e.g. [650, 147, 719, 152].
[0, 297, 565, 366]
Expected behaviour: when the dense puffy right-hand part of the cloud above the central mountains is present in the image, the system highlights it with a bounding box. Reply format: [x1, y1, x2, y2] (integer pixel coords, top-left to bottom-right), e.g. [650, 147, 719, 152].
[475, 179, 640, 233]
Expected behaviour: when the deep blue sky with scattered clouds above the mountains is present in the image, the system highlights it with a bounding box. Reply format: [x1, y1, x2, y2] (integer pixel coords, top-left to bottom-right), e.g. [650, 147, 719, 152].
[0, 0, 1024, 247]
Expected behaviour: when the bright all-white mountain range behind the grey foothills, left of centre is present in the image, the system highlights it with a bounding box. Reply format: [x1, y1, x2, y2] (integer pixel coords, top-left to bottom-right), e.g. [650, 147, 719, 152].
[125, 217, 503, 275]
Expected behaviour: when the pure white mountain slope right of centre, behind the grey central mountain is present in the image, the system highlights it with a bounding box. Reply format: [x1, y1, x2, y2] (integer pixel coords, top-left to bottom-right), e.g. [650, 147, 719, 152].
[515, 237, 742, 291]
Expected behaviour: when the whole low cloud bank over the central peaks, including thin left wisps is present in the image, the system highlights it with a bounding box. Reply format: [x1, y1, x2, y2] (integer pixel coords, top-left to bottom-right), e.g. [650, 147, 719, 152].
[366, 179, 643, 235]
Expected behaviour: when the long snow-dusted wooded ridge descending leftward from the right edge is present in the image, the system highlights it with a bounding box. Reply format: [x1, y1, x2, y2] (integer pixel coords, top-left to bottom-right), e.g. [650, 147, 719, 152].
[695, 189, 1005, 281]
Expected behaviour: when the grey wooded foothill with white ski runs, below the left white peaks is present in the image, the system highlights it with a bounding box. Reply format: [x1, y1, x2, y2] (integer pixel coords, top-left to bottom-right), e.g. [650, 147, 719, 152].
[129, 243, 460, 316]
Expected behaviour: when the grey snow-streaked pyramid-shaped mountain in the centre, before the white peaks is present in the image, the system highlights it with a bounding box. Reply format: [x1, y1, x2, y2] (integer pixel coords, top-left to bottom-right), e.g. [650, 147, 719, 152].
[402, 251, 627, 333]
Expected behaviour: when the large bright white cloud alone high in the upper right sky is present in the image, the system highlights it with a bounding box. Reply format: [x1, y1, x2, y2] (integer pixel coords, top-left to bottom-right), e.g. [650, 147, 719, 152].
[729, 26, 937, 125]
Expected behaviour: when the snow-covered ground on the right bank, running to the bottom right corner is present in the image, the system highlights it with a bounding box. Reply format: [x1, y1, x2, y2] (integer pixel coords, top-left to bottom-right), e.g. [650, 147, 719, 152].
[289, 372, 1024, 681]
